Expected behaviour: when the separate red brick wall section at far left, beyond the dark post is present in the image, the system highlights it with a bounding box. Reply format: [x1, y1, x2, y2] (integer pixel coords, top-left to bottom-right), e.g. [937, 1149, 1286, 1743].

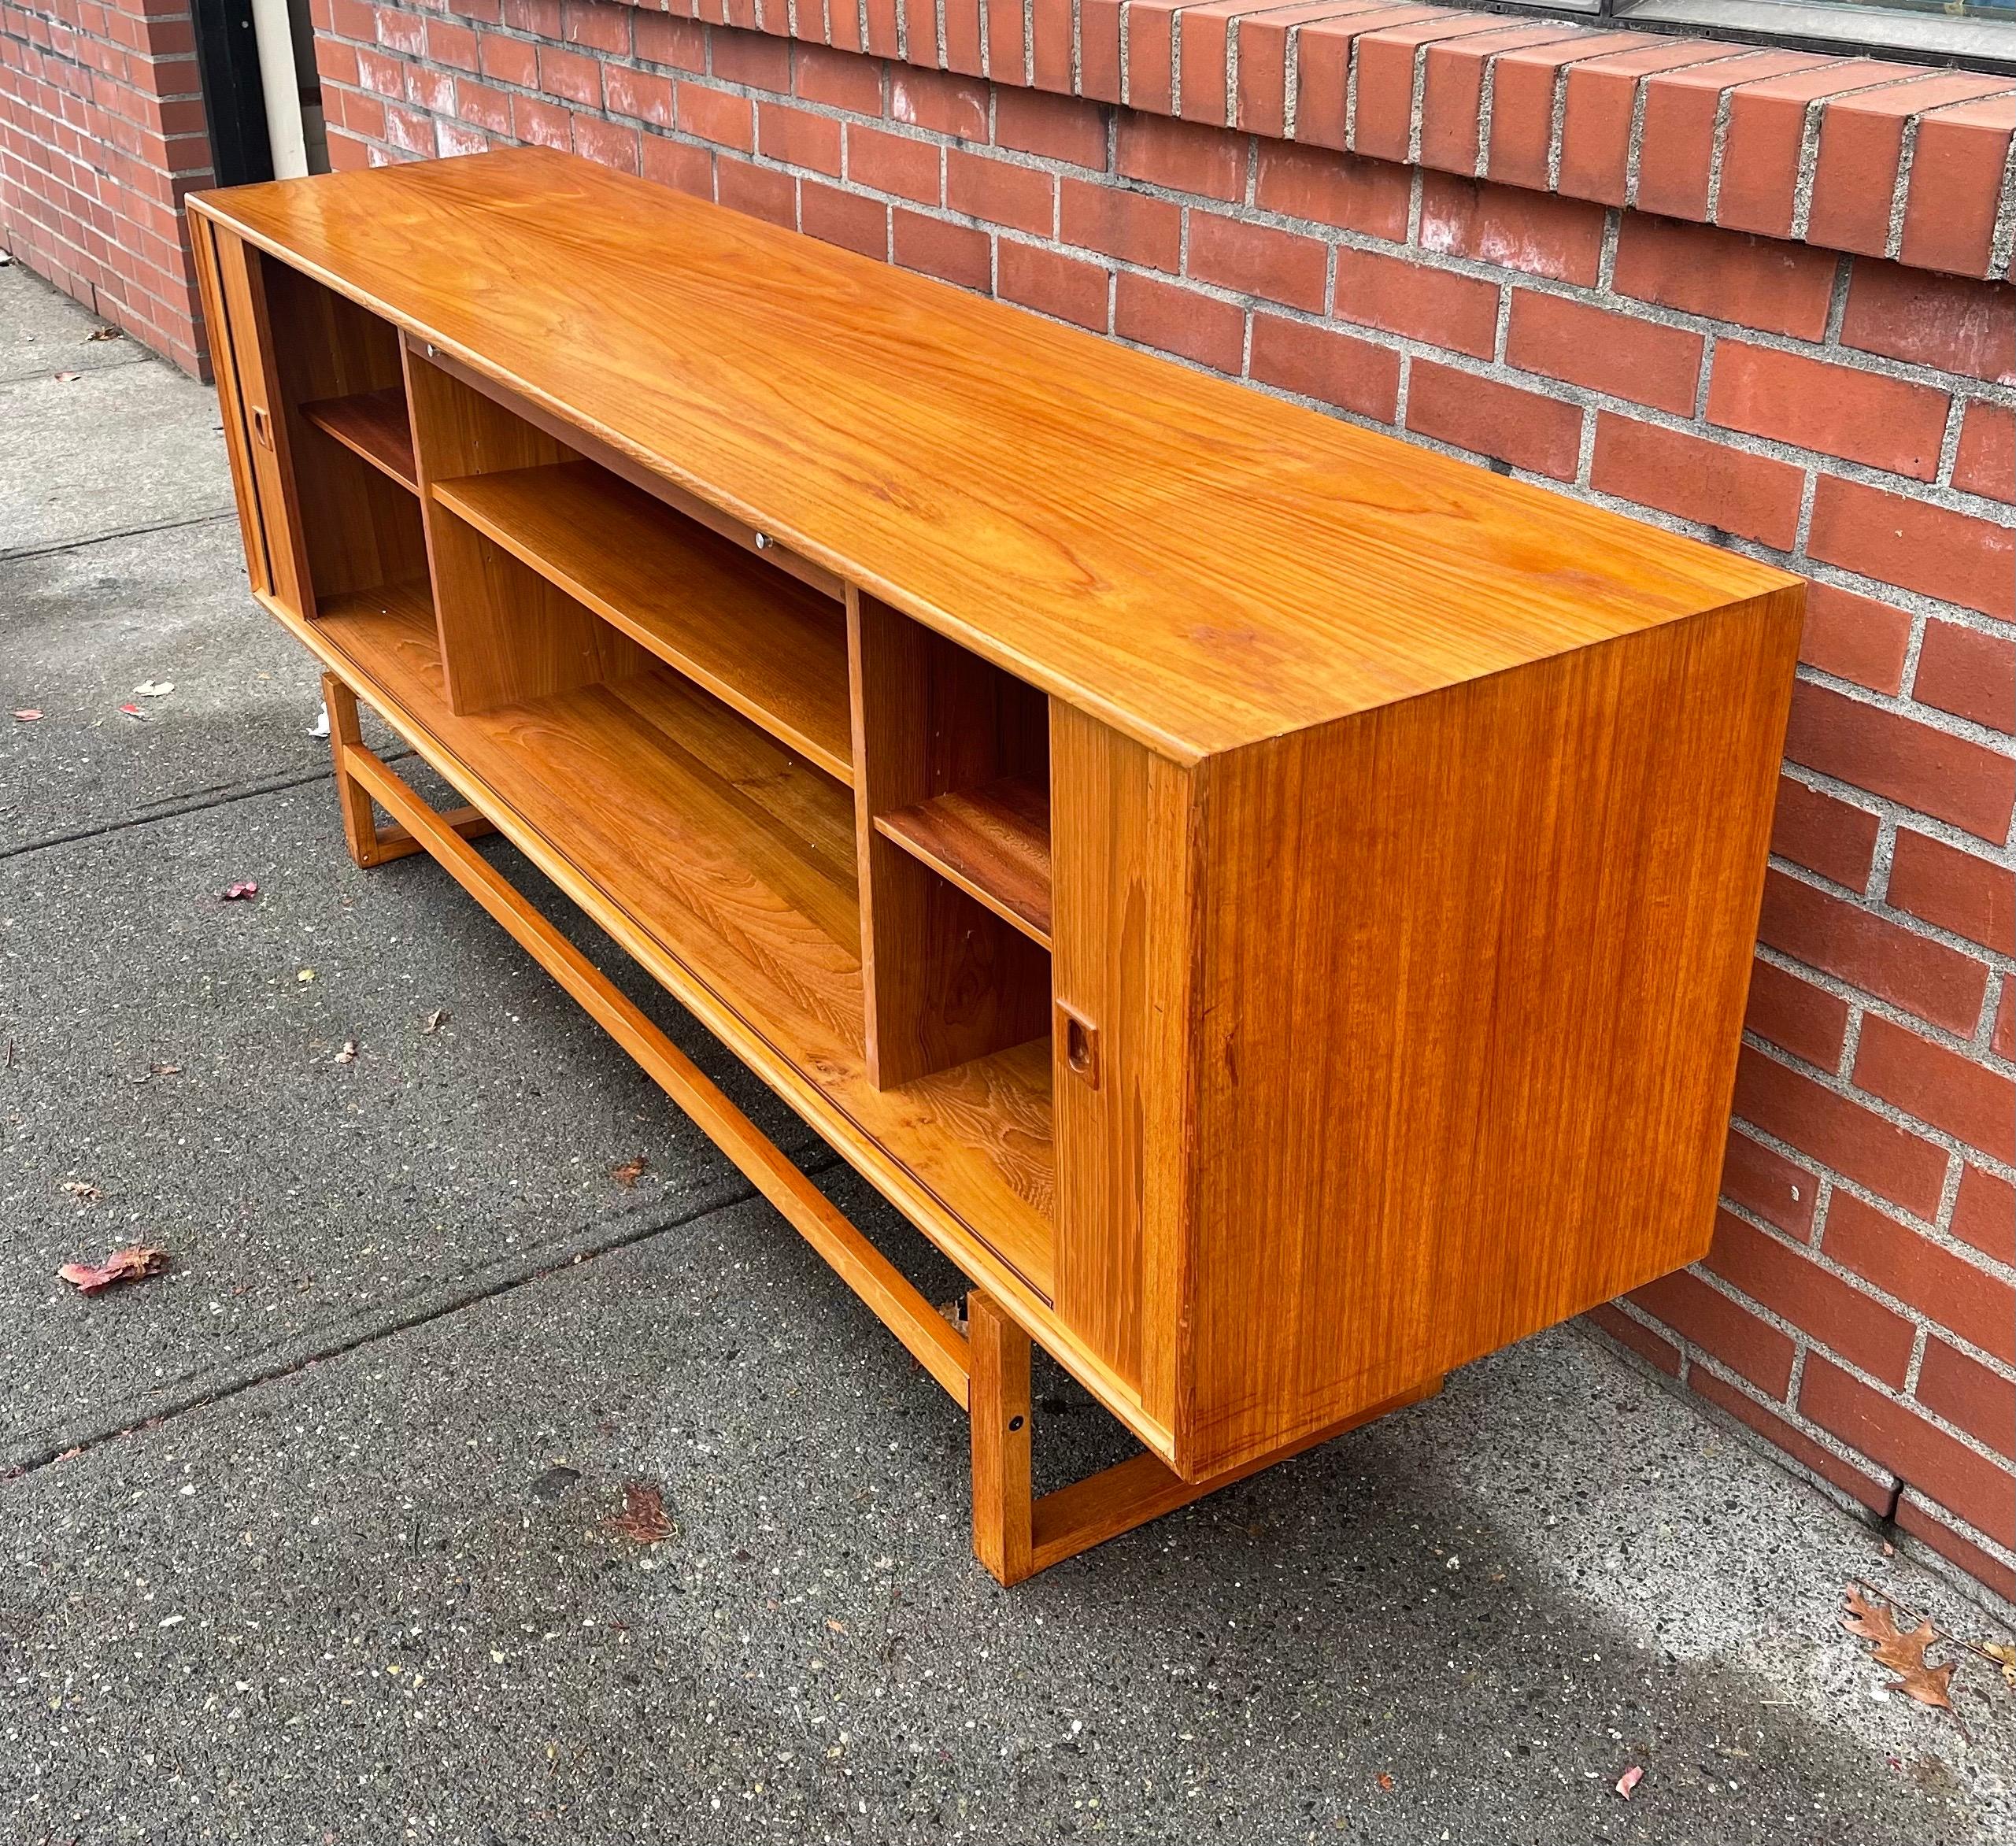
[0, 0, 209, 373]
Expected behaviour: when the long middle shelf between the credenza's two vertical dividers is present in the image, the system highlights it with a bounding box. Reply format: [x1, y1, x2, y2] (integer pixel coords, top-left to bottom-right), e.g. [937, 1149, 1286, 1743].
[434, 461, 855, 784]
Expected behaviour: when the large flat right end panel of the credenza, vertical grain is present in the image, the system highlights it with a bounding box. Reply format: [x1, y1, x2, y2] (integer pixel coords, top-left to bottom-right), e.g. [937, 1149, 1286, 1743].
[1182, 589, 1803, 1471]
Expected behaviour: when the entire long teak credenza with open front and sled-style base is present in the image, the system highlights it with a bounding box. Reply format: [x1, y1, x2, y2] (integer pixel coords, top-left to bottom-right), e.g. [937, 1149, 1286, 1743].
[191, 149, 1803, 1582]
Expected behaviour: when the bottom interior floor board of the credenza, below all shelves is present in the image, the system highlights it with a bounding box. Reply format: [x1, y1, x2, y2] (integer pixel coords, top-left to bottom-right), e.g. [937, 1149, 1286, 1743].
[315, 584, 1054, 1300]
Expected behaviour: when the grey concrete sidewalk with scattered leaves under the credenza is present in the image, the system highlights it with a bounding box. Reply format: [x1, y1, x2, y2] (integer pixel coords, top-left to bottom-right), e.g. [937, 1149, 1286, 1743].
[0, 268, 2016, 1846]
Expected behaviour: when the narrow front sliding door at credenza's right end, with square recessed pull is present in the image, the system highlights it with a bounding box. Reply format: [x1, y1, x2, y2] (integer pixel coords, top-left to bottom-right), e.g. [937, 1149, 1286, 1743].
[1050, 701, 1196, 1427]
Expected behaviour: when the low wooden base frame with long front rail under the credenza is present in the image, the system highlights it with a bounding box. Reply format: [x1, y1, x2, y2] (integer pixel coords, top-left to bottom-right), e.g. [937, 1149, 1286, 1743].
[323, 673, 1441, 1586]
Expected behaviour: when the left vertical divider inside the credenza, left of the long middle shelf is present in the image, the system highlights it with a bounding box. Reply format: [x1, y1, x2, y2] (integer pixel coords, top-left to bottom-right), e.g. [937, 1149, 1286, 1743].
[405, 338, 649, 713]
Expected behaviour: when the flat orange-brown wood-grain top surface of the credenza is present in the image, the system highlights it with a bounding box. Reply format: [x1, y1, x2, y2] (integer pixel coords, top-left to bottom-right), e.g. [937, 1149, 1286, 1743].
[194, 147, 1796, 762]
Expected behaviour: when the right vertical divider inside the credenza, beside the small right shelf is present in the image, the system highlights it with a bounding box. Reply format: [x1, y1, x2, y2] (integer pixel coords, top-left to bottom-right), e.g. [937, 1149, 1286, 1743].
[847, 589, 1050, 1090]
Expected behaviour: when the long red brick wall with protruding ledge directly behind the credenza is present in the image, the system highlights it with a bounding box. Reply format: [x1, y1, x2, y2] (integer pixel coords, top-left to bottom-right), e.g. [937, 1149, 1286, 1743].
[335, 0, 2016, 1594]
